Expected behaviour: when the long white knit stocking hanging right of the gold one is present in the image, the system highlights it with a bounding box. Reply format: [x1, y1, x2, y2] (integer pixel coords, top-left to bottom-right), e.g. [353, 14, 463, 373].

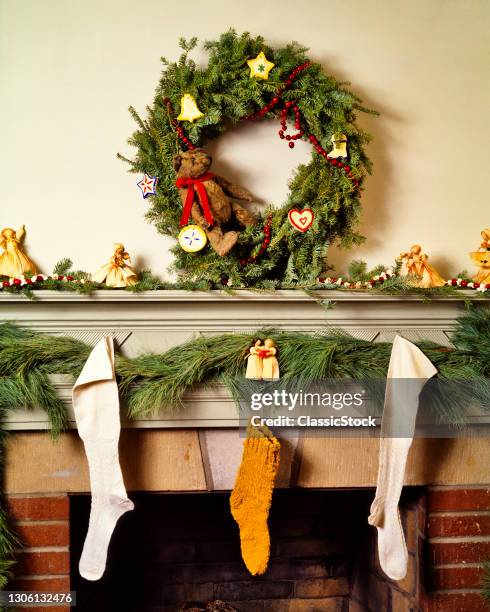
[368, 336, 437, 580]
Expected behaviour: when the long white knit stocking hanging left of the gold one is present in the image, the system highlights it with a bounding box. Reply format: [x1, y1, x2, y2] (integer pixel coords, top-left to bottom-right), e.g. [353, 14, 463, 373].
[73, 337, 134, 580]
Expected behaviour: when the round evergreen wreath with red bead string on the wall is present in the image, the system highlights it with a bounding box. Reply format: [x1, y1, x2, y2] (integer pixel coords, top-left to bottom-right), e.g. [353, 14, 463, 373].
[118, 29, 375, 288]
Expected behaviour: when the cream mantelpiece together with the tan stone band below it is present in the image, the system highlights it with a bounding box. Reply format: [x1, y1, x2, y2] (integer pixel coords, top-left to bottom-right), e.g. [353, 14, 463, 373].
[0, 291, 490, 493]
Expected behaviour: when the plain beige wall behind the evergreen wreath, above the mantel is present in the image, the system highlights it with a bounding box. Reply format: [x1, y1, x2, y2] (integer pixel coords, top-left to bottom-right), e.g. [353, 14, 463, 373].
[0, 0, 490, 278]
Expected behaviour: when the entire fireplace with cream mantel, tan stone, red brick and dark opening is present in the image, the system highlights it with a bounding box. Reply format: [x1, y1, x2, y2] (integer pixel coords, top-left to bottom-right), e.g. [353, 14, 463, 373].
[0, 291, 490, 612]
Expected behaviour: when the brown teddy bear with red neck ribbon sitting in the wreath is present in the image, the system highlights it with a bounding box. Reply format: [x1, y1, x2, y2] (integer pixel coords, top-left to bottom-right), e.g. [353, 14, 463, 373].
[174, 149, 257, 256]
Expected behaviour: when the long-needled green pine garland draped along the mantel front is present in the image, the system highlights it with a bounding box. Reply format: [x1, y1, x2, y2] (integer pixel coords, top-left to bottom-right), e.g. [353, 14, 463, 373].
[0, 307, 490, 588]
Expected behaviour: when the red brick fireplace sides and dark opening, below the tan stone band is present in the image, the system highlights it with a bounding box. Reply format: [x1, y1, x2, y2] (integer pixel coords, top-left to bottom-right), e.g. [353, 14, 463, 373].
[8, 487, 490, 612]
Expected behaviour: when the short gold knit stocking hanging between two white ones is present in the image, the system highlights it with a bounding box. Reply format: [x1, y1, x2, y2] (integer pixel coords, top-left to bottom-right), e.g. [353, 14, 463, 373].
[230, 425, 281, 576]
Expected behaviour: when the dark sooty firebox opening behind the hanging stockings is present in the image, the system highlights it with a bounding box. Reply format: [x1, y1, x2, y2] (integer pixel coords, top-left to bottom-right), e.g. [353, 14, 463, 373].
[70, 489, 421, 612]
